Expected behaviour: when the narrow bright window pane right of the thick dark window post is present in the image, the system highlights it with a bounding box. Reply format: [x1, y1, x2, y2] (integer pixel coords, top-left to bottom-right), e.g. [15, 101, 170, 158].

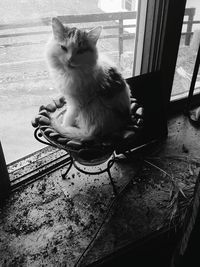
[171, 0, 200, 100]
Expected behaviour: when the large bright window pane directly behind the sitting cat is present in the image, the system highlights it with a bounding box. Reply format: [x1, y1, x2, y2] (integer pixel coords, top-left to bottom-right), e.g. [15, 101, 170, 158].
[0, 0, 141, 163]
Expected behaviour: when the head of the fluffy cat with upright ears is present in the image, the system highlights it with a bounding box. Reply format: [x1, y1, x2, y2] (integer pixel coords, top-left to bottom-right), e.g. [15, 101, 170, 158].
[47, 18, 102, 69]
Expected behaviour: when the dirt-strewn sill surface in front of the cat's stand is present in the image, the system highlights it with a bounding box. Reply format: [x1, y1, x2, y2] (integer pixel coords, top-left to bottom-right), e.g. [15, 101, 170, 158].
[0, 114, 200, 266]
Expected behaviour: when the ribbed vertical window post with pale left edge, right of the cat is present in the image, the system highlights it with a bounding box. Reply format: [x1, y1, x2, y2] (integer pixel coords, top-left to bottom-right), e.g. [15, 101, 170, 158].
[133, 0, 170, 75]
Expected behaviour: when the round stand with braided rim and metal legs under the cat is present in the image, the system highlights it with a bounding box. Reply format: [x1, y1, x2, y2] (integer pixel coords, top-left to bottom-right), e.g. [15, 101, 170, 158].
[32, 97, 144, 196]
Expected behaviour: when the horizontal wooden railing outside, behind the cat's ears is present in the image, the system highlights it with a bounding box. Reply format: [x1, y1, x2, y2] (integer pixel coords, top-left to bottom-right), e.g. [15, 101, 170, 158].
[0, 11, 137, 56]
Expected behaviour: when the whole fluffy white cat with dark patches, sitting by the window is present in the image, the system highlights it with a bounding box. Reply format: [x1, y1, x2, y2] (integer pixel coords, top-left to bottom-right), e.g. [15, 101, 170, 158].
[46, 18, 130, 140]
